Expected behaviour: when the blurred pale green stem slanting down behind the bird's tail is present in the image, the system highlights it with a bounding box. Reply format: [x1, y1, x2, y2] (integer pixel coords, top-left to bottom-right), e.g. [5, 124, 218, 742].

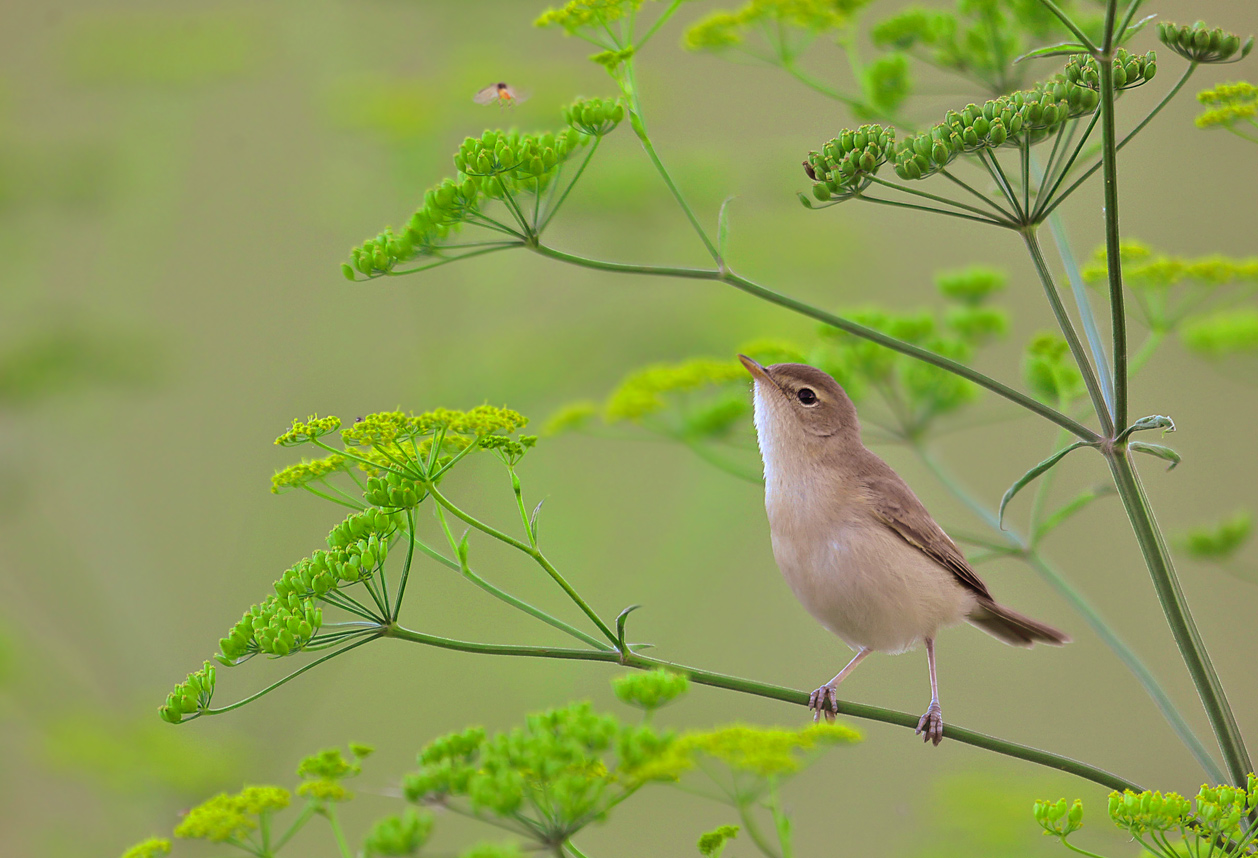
[913, 444, 1224, 784]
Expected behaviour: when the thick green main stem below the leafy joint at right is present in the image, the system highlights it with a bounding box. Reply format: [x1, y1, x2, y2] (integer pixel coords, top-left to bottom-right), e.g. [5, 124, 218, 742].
[1106, 447, 1253, 786]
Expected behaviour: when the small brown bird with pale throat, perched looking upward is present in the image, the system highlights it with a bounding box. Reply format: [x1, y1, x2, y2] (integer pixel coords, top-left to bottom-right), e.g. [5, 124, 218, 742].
[738, 355, 1069, 745]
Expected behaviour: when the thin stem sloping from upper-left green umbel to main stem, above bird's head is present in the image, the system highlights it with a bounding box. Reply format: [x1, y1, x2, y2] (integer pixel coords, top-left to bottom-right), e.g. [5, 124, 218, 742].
[531, 244, 1101, 442]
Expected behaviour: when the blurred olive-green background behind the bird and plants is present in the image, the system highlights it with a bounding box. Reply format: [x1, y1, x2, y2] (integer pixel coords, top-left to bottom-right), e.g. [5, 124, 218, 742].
[0, 0, 1258, 858]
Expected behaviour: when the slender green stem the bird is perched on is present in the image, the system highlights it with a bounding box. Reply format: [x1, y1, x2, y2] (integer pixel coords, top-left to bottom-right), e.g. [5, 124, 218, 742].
[381, 624, 1142, 793]
